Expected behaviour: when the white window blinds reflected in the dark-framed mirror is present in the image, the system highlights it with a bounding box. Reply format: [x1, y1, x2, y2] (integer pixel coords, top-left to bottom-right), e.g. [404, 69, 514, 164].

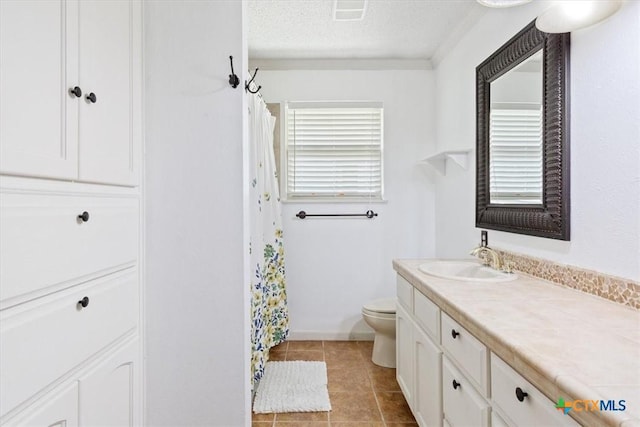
[489, 107, 542, 204]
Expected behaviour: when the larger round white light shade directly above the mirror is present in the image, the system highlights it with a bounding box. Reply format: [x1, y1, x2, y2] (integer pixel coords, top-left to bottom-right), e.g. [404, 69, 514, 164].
[536, 0, 622, 33]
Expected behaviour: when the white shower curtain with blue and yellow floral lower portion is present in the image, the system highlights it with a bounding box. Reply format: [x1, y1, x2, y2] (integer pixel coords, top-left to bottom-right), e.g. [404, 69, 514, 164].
[249, 94, 289, 385]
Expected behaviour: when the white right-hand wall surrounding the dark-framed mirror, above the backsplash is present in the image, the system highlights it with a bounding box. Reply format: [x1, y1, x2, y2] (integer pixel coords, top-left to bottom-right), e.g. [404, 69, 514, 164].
[436, 1, 640, 280]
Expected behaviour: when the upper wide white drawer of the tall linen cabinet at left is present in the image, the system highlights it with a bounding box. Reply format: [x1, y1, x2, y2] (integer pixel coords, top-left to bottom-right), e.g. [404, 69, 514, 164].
[0, 193, 139, 301]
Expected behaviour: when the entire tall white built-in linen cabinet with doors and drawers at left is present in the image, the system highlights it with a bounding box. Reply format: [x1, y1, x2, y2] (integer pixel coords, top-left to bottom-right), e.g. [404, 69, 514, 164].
[0, 0, 142, 426]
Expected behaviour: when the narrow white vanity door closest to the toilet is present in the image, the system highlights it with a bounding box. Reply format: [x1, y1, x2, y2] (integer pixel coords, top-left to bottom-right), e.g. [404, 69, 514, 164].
[396, 305, 414, 409]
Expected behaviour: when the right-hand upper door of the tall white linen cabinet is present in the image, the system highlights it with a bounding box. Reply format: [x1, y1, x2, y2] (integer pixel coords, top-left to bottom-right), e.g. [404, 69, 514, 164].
[79, 0, 142, 185]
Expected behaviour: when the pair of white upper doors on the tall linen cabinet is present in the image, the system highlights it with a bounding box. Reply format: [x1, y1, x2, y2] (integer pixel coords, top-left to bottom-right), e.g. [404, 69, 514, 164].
[0, 0, 142, 186]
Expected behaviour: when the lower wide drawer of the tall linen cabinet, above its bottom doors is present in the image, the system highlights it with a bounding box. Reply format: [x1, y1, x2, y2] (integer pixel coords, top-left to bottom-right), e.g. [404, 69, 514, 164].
[0, 268, 138, 416]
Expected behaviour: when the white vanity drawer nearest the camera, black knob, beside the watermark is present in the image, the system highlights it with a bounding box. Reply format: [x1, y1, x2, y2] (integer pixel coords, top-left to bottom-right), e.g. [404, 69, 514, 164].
[491, 354, 578, 426]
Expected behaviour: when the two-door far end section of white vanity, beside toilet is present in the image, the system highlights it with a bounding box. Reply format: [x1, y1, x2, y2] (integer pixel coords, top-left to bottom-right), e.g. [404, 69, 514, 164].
[396, 276, 442, 426]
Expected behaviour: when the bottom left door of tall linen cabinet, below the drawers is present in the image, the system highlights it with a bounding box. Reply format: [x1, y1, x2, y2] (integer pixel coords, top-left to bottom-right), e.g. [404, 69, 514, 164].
[3, 381, 78, 427]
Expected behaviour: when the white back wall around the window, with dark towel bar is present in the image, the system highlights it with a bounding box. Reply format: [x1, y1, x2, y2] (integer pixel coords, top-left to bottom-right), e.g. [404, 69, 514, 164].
[256, 70, 435, 339]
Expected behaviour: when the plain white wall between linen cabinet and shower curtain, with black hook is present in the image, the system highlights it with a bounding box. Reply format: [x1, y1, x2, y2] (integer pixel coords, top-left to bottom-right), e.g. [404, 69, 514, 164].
[145, 0, 250, 426]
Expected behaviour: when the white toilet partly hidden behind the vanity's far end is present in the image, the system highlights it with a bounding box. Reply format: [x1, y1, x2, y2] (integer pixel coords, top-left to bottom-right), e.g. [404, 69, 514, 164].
[362, 298, 396, 368]
